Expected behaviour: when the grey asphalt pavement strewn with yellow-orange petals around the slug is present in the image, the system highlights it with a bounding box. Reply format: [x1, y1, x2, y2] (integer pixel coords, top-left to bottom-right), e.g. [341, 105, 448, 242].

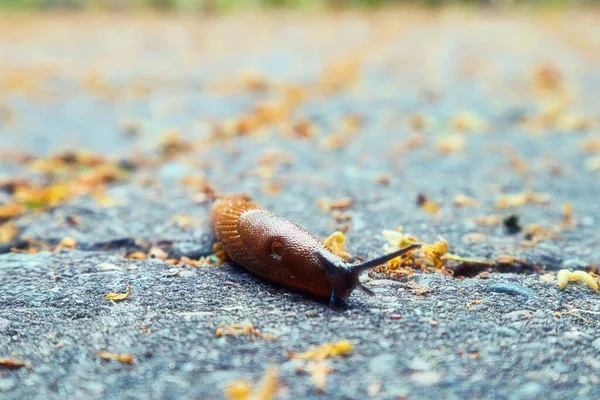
[0, 9, 600, 399]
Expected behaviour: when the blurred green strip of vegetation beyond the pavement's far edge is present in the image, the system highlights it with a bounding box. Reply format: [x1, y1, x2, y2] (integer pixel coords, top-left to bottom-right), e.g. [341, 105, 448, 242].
[0, 0, 600, 12]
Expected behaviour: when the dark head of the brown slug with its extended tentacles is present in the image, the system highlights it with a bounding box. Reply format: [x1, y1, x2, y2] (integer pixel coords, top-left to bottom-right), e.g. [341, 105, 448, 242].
[314, 243, 421, 304]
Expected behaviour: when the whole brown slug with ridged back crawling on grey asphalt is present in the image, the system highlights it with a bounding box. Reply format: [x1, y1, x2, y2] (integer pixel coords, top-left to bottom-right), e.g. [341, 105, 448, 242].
[211, 196, 421, 304]
